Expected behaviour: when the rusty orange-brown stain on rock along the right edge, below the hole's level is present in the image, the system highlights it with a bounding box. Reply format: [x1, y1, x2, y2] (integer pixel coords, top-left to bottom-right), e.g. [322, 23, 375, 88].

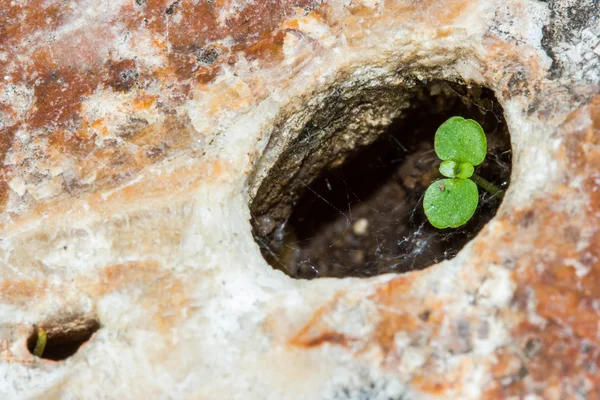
[485, 97, 600, 398]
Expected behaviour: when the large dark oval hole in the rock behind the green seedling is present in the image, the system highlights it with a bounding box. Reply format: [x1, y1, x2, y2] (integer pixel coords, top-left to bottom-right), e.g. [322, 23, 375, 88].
[250, 81, 511, 279]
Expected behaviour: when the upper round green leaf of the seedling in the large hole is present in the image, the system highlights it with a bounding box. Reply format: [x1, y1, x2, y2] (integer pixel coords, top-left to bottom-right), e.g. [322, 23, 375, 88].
[434, 117, 487, 165]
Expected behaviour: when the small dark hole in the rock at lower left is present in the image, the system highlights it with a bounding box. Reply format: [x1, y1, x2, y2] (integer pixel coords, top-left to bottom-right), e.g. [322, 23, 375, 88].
[27, 319, 100, 361]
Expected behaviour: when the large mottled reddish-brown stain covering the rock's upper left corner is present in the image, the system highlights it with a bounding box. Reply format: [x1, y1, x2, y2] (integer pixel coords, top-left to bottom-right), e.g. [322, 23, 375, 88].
[0, 0, 324, 210]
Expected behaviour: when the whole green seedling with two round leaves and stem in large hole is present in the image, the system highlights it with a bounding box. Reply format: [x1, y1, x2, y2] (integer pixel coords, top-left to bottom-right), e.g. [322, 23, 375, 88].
[423, 117, 504, 229]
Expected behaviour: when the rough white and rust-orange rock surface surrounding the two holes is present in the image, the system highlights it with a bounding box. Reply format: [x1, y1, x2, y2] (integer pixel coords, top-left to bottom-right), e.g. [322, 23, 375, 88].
[0, 0, 600, 399]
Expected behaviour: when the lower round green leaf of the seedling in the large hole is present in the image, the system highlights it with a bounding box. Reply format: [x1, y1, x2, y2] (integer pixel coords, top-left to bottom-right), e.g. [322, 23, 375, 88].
[423, 179, 479, 229]
